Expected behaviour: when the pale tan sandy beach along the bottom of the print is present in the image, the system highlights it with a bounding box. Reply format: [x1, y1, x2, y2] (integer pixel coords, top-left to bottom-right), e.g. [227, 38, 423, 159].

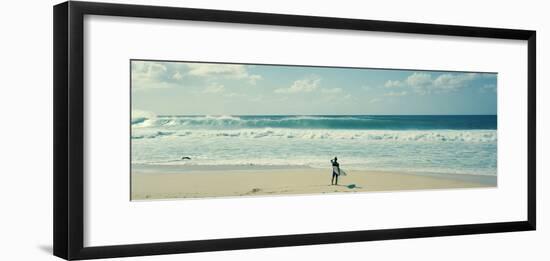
[131, 165, 496, 200]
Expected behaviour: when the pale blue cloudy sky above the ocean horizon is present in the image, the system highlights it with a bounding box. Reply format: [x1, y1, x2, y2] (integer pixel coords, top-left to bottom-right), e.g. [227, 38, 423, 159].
[131, 60, 497, 115]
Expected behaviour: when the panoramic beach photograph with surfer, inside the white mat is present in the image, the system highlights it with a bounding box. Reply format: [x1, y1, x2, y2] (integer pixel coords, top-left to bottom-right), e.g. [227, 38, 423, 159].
[130, 60, 497, 200]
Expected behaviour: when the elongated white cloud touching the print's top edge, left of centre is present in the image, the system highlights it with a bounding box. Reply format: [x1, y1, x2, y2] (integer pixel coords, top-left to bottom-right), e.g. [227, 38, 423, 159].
[187, 63, 262, 84]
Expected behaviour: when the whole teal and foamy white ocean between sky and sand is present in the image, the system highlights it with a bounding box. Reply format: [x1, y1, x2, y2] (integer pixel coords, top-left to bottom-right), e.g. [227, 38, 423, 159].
[131, 113, 497, 176]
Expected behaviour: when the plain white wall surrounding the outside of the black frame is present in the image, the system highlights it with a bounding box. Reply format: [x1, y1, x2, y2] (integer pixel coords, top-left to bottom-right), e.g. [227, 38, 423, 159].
[0, 0, 550, 261]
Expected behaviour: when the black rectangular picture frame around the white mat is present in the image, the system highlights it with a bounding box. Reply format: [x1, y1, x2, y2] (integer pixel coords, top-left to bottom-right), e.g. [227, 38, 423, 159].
[53, 1, 536, 260]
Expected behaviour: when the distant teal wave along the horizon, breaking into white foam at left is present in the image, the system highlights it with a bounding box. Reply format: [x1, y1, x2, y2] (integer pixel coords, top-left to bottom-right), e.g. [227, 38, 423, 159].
[132, 113, 496, 130]
